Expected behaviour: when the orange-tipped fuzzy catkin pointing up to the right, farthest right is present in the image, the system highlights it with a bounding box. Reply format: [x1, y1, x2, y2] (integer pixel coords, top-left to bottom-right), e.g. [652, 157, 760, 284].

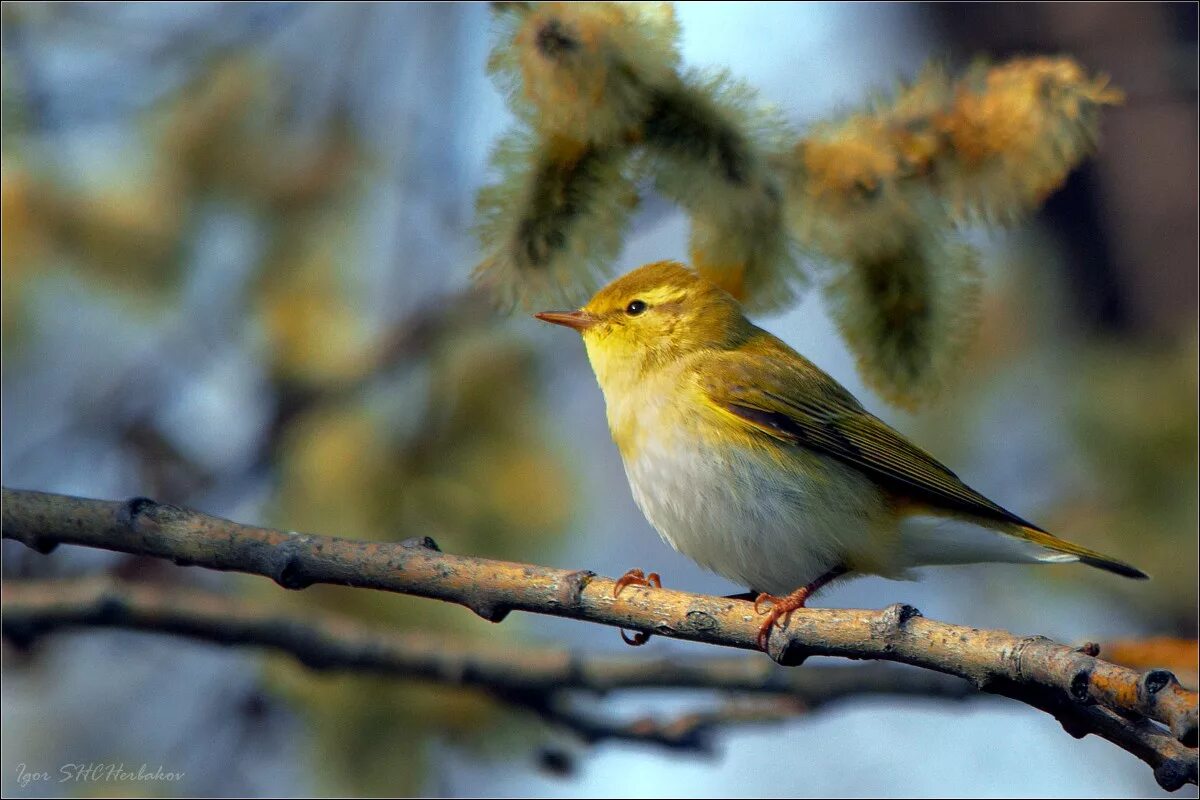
[788, 58, 1121, 237]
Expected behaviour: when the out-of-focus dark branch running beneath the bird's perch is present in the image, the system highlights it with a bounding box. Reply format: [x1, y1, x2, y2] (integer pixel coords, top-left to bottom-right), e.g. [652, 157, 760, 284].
[2, 578, 989, 751]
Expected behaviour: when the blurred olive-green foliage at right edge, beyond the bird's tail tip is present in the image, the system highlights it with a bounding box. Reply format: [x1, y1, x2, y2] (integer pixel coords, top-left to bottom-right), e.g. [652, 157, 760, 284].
[1060, 329, 1200, 634]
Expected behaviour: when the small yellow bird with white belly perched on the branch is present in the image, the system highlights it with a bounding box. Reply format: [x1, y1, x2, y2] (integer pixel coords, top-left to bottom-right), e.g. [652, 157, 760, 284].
[534, 260, 1147, 650]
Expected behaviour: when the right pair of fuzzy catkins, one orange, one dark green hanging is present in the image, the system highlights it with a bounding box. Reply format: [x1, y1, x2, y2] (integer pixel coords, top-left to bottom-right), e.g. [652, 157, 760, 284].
[786, 58, 1120, 407]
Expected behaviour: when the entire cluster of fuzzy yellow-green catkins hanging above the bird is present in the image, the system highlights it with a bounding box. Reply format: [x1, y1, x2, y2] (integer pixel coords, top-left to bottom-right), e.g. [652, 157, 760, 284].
[476, 2, 1121, 407]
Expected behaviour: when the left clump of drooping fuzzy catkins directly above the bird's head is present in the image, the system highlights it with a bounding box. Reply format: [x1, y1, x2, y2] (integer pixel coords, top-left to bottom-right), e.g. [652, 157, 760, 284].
[475, 2, 804, 309]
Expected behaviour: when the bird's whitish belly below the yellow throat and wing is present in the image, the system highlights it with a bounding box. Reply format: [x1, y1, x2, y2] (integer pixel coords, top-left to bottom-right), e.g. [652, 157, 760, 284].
[625, 426, 892, 595]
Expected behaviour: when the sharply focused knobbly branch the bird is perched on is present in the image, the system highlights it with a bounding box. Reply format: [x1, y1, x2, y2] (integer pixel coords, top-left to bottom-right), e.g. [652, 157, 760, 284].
[4, 489, 1196, 790]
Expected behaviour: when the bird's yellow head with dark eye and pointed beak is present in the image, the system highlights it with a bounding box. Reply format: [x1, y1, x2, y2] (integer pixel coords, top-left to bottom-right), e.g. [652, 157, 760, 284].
[534, 261, 751, 386]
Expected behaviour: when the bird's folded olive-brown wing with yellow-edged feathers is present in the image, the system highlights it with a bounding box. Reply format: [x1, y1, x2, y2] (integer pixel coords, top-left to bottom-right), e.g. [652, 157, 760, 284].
[695, 333, 1044, 533]
